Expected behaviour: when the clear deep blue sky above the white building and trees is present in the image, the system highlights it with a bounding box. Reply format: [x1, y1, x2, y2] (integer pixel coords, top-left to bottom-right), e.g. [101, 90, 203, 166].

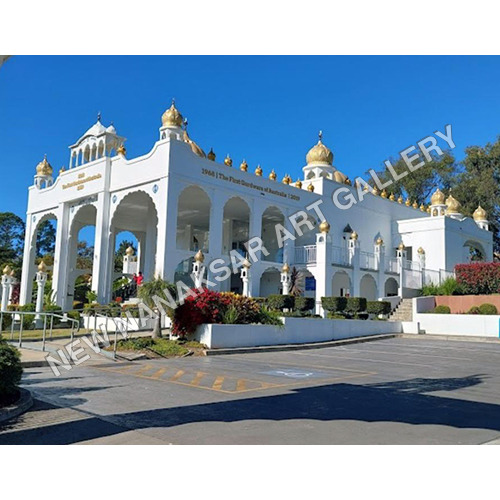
[0, 56, 500, 223]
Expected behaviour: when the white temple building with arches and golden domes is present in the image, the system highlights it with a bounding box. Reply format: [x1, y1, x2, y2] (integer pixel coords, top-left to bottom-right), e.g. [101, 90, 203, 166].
[17, 103, 493, 310]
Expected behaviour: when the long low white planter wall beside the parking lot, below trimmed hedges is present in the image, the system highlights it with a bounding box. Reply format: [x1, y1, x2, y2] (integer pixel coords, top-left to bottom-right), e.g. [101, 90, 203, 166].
[194, 318, 402, 349]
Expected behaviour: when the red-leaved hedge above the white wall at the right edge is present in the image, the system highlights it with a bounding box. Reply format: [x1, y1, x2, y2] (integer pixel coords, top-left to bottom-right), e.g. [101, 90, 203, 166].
[455, 262, 500, 295]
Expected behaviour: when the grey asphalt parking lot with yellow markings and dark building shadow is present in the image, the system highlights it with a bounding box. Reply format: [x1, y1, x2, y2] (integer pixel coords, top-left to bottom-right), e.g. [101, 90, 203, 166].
[0, 337, 500, 444]
